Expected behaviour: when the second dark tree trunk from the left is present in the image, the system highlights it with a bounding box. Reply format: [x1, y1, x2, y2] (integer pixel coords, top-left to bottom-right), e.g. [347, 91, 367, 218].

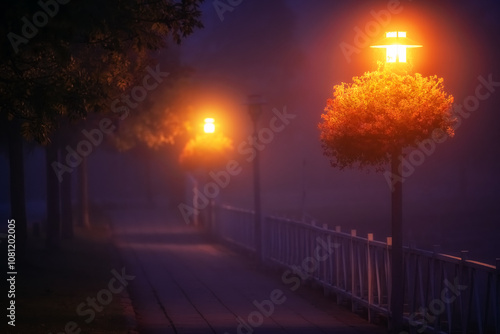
[45, 139, 61, 251]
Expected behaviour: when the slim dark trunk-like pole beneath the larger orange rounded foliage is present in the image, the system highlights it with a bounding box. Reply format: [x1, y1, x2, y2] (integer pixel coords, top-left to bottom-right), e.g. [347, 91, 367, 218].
[390, 149, 404, 333]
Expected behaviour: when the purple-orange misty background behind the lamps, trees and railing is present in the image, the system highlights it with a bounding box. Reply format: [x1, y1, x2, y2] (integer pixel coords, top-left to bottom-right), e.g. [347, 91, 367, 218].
[0, 0, 500, 263]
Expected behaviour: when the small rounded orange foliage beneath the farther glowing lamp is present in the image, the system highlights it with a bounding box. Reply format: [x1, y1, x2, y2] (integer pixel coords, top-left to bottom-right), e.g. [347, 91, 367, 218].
[179, 133, 233, 170]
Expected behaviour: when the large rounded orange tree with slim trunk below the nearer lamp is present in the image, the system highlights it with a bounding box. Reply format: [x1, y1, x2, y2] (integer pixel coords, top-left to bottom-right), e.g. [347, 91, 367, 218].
[319, 63, 454, 333]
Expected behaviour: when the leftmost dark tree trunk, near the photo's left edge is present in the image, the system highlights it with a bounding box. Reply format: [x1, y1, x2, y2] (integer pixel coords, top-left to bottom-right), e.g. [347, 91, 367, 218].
[8, 121, 28, 260]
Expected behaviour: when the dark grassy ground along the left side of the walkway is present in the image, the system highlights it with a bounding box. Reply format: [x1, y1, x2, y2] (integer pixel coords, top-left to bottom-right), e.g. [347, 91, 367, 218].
[8, 227, 131, 334]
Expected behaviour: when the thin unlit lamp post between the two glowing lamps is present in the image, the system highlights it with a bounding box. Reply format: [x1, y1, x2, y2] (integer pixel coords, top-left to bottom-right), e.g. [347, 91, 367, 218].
[247, 94, 265, 262]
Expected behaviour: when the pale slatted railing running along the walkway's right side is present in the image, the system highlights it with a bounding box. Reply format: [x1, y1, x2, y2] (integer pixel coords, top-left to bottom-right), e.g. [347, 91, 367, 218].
[212, 206, 500, 334]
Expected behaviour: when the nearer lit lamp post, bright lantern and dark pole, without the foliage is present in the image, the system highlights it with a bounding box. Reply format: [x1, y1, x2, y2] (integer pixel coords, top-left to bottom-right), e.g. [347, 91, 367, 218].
[371, 31, 422, 333]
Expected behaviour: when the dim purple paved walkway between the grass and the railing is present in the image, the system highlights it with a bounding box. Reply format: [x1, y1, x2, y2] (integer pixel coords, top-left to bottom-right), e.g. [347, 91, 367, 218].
[112, 210, 385, 334]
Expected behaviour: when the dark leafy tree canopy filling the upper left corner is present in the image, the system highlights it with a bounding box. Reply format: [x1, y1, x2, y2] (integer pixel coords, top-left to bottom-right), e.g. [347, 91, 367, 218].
[0, 0, 201, 143]
